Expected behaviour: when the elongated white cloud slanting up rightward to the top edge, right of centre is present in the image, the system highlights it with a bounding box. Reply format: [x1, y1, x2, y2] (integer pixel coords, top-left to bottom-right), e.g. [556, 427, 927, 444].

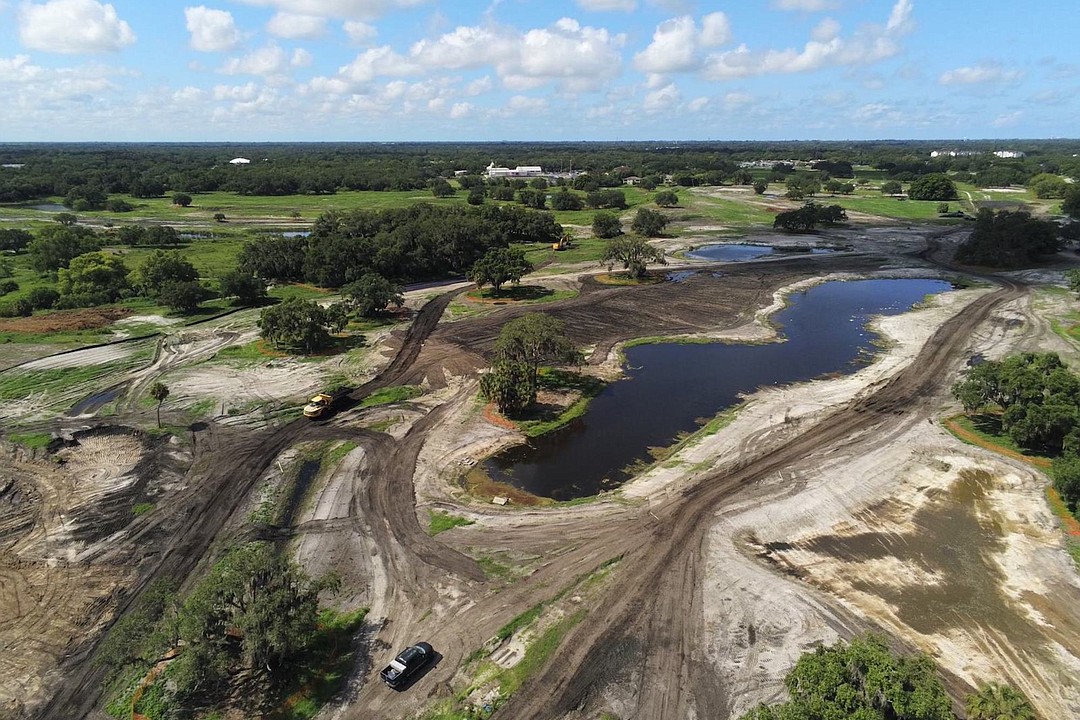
[704, 0, 914, 80]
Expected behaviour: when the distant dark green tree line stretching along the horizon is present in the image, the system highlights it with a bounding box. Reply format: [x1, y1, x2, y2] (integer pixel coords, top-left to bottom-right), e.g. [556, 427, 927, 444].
[0, 140, 1080, 202]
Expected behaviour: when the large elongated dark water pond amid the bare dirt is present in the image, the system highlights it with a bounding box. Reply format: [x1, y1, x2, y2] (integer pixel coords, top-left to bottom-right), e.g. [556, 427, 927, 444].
[485, 280, 950, 500]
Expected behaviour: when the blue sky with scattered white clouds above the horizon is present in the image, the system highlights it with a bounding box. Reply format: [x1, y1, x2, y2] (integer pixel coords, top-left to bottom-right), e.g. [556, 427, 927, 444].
[0, 0, 1080, 142]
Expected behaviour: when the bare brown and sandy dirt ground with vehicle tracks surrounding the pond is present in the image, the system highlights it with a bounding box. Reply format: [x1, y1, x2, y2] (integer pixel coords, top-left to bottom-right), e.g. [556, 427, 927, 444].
[0, 228, 1080, 720]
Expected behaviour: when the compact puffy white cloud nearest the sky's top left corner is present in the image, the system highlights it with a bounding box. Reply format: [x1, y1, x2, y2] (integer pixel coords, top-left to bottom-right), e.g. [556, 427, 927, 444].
[18, 0, 135, 54]
